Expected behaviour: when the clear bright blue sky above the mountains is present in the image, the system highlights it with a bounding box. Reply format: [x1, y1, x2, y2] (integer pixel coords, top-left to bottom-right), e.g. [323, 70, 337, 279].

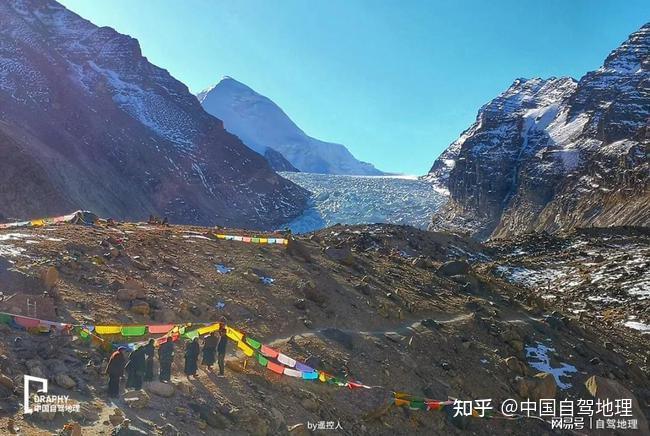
[60, 0, 650, 175]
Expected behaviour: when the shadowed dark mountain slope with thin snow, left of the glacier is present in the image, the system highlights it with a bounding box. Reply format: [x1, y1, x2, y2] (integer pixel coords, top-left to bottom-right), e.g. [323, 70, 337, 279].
[0, 0, 307, 227]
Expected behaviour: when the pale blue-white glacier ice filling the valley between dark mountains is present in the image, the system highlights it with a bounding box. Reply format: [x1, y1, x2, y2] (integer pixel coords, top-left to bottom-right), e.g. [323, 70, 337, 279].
[280, 173, 445, 233]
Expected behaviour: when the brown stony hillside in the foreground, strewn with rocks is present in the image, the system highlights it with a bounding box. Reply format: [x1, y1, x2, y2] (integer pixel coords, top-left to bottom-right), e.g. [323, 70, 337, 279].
[0, 223, 650, 435]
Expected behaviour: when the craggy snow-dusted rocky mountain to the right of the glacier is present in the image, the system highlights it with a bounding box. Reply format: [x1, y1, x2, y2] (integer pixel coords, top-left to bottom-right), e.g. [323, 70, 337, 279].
[427, 24, 650, 242]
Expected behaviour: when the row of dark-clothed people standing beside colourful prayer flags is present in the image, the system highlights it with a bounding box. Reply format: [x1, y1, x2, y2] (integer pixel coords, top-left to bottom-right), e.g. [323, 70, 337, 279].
[106, 325, 228, 397]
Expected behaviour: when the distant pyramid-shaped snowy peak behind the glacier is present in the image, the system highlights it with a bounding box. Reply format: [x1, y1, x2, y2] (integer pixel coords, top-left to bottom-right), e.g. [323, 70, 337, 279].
[198, 77, 383, 175]
